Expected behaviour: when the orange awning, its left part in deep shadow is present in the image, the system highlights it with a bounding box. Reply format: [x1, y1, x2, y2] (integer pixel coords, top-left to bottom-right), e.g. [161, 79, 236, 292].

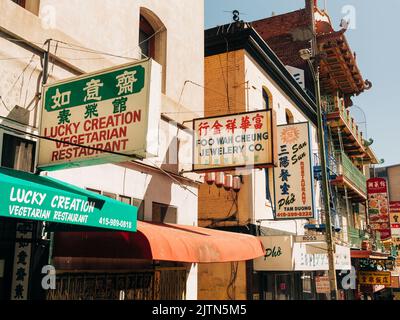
[53, 221, 264, 263]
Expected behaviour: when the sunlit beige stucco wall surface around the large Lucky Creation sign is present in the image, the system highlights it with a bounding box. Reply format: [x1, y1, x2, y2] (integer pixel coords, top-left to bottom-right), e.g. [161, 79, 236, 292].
[0, 0, 204, 299]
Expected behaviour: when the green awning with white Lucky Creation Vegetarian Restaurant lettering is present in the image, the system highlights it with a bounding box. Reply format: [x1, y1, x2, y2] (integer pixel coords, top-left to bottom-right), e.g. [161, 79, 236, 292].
[0, 167, 138, 232]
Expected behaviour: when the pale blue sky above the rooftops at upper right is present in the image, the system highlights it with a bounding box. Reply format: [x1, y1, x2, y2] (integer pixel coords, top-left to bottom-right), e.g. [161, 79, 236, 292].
[205, 0, 400, 166]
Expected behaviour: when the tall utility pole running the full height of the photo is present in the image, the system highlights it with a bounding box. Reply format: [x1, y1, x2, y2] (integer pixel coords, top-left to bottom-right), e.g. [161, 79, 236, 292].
[307, 0, 338, 300]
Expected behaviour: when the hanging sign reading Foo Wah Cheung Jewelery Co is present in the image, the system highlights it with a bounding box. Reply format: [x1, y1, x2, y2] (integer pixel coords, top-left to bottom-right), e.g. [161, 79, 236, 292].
[193, 110, 274, 172]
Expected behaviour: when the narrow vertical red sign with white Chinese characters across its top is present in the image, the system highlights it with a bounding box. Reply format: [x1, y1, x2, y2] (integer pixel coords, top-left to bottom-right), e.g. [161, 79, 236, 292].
[367, 178, 391, 239]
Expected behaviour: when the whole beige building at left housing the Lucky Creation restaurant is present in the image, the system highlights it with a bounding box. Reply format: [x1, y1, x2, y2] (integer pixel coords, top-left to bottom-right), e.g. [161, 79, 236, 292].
[0, 0, 262, 300]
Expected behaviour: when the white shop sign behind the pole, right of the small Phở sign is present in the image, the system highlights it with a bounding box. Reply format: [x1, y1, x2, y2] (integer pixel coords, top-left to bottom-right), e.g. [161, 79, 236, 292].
[293, 242, 351, 271]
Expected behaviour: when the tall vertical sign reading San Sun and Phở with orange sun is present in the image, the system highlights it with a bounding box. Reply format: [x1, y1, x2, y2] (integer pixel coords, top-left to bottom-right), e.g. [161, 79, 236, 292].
[274, 122, 314, 219]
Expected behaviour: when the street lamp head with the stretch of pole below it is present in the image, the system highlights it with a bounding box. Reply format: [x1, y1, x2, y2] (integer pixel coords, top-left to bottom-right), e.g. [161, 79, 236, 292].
[299, 49, 337, 300]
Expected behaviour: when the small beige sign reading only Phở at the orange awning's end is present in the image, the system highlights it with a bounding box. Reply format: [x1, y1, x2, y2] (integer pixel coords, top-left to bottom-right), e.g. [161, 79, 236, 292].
[254, 236, 293, 271]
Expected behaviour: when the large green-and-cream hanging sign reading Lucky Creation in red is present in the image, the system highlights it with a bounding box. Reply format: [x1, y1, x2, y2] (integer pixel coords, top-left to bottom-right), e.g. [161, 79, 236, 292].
[38, 60, 161, 170]
